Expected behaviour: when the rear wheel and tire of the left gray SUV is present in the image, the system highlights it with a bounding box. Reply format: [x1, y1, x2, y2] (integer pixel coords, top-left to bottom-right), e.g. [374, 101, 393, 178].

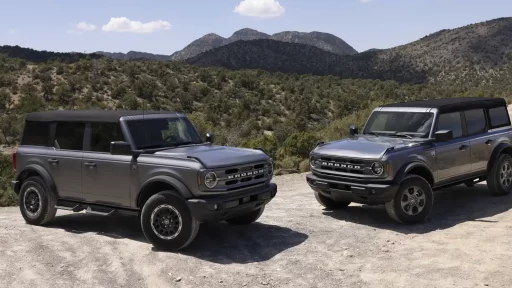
[18, 176, 57, 226]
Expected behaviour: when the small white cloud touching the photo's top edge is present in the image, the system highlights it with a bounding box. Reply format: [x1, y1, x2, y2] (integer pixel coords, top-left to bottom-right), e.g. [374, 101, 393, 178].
[234, 0, 284, 18]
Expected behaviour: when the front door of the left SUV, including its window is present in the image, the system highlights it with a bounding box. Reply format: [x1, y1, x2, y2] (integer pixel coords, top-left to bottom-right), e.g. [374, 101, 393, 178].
[81, 123, 132, 207]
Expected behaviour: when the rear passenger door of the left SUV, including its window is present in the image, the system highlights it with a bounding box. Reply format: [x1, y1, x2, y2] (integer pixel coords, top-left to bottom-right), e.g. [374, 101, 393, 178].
[46, 122, 85, 200]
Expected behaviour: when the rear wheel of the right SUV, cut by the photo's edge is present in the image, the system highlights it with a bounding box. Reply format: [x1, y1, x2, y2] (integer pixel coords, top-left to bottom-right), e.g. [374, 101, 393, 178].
[487, 154, 512, 196]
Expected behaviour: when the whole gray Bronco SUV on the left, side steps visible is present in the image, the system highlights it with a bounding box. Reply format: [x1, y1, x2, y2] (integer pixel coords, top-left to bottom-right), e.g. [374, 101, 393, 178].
[12, 110, 277, 250]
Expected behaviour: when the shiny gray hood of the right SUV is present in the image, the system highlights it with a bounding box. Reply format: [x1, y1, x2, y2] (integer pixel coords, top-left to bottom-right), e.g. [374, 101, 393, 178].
[312, 135, 423, 159]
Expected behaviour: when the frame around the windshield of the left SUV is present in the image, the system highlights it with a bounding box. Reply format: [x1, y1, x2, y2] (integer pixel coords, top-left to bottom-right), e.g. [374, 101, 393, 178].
[120, 113, 205, 150]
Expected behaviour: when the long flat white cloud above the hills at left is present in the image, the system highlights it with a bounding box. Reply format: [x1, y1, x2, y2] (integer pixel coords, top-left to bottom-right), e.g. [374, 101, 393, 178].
[101, 17, 171, 33]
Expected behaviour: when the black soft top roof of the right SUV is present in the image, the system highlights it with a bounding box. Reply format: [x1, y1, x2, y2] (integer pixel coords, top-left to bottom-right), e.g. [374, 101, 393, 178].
[381, 97, 507, 112]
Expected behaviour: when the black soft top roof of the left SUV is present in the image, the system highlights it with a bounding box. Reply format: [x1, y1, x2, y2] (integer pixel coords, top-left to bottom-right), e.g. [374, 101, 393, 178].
[25, 110, 180, 122]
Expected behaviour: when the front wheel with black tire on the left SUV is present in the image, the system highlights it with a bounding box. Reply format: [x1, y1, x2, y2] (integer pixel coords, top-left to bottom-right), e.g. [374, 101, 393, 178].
[140, 191, 200, 251]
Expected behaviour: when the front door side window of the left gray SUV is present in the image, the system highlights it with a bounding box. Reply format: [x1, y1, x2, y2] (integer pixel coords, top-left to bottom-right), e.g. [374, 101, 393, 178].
[89, 123, 125, 152]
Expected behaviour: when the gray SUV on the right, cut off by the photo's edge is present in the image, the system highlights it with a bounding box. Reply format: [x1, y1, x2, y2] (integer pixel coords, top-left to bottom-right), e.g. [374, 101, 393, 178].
[307, 98, 512, 224]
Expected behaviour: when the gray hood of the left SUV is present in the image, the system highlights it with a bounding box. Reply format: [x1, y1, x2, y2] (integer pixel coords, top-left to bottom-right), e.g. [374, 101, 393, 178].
[154, 144, 270, 169]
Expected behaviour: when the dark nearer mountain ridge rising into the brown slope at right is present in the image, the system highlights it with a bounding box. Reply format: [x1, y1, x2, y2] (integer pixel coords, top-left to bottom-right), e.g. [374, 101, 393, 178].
[185, 17, 512, 83]
